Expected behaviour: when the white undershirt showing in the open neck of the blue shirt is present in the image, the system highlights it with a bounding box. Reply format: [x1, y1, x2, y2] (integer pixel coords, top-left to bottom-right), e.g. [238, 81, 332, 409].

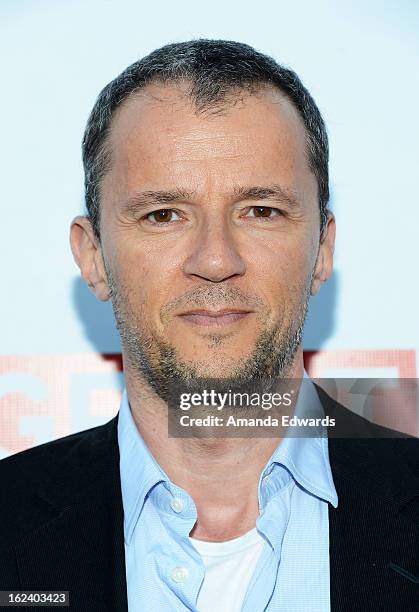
[189, 527, 264, 612]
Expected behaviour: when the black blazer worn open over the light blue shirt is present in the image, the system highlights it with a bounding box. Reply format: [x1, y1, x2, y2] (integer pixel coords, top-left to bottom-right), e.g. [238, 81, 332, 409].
[0, 387, 419, 612]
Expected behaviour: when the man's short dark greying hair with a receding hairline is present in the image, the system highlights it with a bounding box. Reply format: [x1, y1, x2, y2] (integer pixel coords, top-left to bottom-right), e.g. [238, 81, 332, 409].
[82, 39, 329, 242]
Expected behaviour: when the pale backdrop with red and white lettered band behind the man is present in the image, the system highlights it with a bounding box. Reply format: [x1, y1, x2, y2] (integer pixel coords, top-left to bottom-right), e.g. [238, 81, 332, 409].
[0, 0, 419, 457]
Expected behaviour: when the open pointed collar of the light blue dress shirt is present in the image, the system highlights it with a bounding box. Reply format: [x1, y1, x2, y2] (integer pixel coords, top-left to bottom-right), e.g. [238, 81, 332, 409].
[118, 371, 337, 543]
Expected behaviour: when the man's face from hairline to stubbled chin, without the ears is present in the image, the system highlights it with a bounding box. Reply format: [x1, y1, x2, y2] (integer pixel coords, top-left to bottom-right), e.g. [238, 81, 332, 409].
[78, 84, 334, 394]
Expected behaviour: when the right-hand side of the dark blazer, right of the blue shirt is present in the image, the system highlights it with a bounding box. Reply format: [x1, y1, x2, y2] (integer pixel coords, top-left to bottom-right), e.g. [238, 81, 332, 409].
[319, 391, 419, 612]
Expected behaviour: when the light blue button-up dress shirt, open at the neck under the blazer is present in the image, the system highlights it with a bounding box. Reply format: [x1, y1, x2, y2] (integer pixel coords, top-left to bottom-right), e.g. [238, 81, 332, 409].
[118, 373, 338, 612]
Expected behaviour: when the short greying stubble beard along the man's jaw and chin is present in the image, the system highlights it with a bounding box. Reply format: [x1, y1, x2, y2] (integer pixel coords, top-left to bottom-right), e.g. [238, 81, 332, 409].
[105, 265, 312, 402]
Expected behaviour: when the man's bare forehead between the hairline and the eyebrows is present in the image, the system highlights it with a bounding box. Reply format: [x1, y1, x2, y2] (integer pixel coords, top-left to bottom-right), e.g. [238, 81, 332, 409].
[104, 84, 314, 198]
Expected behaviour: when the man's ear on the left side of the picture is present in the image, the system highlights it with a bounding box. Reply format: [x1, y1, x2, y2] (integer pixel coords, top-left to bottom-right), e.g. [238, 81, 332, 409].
[70, 216, 110, 302]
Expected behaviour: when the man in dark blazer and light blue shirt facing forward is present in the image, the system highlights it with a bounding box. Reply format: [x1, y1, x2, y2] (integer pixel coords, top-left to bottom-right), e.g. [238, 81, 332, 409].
[0, 40, 419, 612]
